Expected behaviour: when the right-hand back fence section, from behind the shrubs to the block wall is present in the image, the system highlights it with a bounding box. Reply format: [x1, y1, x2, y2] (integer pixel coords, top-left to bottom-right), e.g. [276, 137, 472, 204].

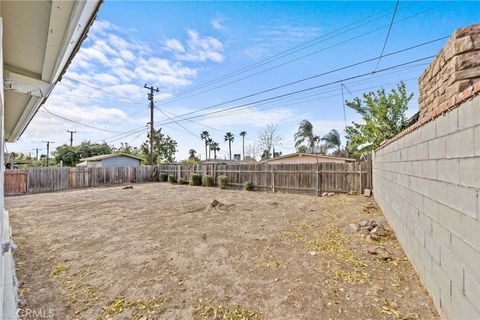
[159, 160, 372, 195]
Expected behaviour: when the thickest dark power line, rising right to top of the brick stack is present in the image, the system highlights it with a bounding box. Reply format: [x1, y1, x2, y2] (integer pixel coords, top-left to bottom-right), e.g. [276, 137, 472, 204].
[162, 36, 449, 122]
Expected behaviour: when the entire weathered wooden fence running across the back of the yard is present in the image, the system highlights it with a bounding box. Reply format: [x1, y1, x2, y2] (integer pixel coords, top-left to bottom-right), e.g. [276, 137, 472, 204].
[1, 161, 372, 195]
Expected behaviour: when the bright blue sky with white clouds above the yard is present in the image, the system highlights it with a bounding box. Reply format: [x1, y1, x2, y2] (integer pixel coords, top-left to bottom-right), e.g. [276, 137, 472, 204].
[7, 1, 480, 160]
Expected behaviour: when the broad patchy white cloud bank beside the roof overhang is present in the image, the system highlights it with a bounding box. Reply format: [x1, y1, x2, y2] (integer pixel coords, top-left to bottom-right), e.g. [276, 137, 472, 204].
[14, 20, 227, 154]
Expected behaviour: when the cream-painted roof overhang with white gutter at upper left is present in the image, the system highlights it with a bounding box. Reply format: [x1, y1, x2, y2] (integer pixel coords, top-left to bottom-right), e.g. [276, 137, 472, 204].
[0, 0, 101, 142]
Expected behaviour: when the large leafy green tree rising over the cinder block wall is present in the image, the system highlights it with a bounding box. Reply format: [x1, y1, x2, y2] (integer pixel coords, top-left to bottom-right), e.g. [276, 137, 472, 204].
[345, 81, 413, 155]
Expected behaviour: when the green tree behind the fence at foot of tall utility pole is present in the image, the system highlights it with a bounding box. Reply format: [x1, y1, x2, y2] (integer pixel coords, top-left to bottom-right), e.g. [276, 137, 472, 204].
[140, 128, 177, 164]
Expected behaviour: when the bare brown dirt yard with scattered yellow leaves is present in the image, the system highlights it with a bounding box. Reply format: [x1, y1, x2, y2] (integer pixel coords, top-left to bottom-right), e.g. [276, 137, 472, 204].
[6, 183, 438, 320]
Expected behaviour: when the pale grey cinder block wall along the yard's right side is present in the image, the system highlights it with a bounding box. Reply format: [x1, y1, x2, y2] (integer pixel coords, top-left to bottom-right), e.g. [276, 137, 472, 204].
[373, 25, 480, 320]
